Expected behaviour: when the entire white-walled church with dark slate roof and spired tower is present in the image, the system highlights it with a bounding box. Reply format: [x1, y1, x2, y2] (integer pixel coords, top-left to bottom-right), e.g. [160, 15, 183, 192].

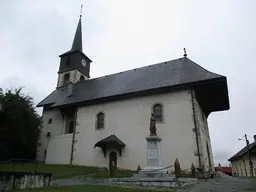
[37, 14, 229, 170]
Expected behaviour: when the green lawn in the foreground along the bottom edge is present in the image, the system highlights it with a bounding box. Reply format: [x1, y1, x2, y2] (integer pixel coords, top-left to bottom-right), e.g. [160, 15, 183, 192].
[18, 185, 174, 192]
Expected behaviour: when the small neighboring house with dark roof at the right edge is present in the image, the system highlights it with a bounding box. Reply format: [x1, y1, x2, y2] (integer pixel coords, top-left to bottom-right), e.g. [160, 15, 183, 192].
[229, 135, 256, 177]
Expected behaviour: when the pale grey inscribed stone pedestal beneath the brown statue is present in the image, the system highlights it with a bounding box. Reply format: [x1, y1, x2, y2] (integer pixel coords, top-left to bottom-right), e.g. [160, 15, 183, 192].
[140, 136, 166, 174]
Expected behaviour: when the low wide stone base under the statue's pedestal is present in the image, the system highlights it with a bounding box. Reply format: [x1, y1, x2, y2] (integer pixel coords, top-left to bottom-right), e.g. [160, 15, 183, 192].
[112, 178, 198, 188]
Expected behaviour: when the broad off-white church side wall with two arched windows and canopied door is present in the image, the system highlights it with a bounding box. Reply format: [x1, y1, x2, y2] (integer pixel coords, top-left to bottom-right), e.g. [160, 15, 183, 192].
[69, 91, 198, 169]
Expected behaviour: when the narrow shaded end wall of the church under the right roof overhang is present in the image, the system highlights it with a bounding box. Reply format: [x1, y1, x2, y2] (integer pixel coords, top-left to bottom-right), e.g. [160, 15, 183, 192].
[194, 94, 214, 170]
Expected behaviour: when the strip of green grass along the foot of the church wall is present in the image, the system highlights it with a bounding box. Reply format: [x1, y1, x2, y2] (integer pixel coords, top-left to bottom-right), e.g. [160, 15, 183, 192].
[0, 163, 134, 179]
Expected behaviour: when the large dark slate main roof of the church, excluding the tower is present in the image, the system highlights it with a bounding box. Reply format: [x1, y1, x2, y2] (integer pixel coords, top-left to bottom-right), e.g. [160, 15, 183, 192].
[37, 57, 229, 113]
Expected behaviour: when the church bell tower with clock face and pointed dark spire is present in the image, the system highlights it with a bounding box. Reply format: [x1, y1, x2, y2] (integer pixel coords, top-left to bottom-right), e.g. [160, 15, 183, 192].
[57, 15, 92, 88]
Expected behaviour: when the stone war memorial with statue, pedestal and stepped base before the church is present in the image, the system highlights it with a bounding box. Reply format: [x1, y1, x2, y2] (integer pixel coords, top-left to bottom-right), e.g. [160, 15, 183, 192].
[112, 113, 197, 188]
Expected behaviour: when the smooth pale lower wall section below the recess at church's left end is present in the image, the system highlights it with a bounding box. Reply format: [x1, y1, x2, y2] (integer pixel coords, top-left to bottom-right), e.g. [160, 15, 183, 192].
[45, 134, 72, 164]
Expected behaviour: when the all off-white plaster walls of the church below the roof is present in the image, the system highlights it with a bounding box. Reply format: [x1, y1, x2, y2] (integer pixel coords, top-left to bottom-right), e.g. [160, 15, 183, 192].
[39, 90, 214, 169]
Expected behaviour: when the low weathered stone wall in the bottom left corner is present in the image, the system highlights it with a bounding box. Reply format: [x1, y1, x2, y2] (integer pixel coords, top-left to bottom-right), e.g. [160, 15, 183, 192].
[0, 171, 53, 190]
